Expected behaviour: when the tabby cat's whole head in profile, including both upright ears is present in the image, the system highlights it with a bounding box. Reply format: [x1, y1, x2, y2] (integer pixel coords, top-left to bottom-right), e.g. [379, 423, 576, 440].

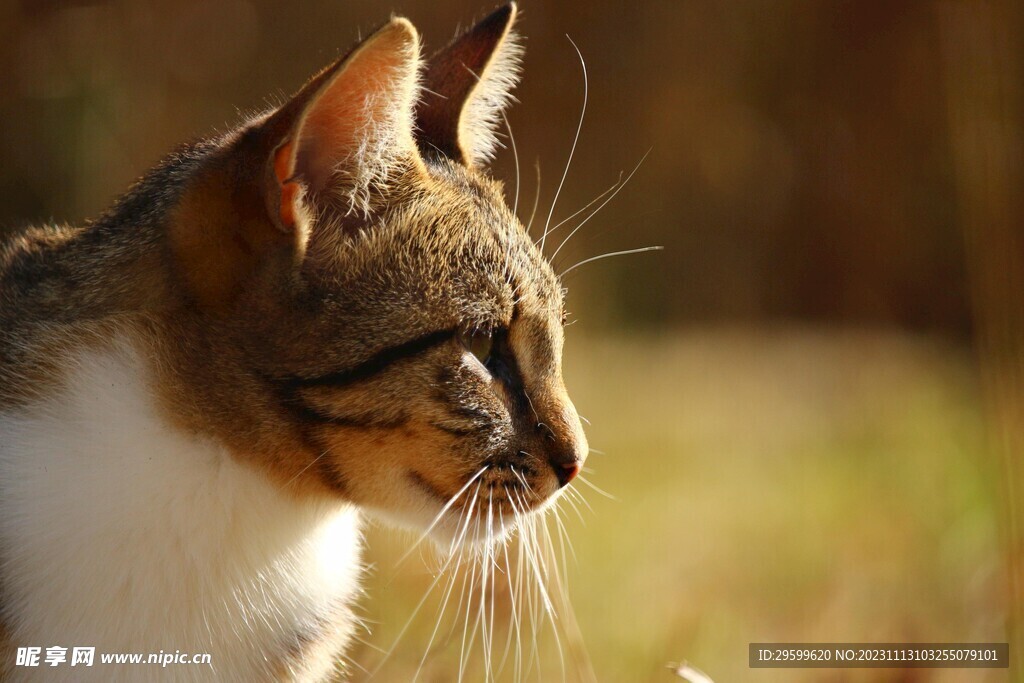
[156, 5, 588, 536]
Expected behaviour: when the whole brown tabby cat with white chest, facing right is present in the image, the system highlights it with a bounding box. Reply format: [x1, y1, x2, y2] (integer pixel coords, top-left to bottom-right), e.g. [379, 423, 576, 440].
[0, 4, 588, 682]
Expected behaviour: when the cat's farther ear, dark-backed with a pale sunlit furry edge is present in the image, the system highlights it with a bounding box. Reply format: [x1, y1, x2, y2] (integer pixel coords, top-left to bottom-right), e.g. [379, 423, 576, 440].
[416, 3, 522, 166]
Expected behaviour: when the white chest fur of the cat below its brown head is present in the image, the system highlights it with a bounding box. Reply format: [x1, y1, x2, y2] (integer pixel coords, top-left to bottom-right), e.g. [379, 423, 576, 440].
[0, 344, 359, 681]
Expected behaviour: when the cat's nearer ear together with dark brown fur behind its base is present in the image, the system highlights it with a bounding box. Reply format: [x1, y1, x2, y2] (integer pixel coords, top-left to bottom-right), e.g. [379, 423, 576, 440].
[168, 18, 425, 307]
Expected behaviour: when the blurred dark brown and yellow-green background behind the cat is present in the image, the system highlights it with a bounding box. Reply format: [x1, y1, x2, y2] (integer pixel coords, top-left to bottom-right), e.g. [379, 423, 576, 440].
[0, 0, 1024, 682]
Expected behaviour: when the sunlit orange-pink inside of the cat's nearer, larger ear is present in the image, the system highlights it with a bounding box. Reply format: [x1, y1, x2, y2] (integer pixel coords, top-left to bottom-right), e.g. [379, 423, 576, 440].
[263, 17, 422, 228]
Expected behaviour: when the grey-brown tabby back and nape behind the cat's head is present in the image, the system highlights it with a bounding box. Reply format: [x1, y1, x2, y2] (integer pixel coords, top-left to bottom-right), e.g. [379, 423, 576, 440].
[0, 141, 209, 408]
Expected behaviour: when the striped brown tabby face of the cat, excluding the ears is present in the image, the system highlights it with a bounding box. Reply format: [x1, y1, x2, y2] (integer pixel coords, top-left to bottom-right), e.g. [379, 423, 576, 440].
[276, 160, 587, 531]
